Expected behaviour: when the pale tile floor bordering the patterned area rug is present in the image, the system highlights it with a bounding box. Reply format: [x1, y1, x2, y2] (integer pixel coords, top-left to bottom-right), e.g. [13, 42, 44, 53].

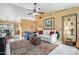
[6, 38, 79, 55]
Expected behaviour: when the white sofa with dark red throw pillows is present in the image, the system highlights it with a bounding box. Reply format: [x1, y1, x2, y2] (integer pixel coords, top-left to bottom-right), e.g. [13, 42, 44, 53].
[37, 30, 58, 43]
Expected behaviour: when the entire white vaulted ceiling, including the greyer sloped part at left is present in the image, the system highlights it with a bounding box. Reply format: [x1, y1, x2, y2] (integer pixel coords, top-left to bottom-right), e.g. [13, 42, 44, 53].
[0, 3, 79, 21]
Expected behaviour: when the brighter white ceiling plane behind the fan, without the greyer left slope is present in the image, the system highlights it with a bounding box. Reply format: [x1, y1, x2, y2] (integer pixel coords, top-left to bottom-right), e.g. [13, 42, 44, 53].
[15, 3, 79, 12]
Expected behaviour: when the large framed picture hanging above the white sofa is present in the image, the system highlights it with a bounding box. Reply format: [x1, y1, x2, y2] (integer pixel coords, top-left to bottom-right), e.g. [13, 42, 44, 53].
[44, 17, 55, 29]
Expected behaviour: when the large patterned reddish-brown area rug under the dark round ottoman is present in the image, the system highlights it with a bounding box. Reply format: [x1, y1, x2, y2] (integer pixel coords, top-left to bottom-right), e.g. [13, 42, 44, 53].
[10, 40, 58, 55]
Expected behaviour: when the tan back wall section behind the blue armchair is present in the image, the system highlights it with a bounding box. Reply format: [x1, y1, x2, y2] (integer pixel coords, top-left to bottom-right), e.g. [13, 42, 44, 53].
[21, 19, 34, 34]
